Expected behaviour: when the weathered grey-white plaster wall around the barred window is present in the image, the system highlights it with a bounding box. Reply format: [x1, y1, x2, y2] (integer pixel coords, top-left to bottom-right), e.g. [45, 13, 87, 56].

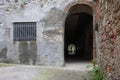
[0, 0, 95, 66]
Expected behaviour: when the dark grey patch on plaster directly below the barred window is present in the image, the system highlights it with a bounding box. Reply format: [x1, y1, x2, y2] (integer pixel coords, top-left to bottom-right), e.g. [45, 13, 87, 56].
[19, 41, 37, 65]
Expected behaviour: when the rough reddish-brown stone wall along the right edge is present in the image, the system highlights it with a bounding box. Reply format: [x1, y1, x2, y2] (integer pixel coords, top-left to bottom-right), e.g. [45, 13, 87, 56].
[97, 0, 120, 80]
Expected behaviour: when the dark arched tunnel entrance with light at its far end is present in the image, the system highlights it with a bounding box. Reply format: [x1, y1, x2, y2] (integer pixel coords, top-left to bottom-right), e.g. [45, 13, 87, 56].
[64, 5, 93, 61]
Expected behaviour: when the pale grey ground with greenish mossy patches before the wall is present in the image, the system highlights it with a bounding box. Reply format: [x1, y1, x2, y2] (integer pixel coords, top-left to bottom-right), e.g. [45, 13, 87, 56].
[0, 63, 91, 80]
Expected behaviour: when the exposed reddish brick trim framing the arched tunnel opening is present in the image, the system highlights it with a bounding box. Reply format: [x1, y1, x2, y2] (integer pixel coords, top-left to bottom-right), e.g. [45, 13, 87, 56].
[64, 0, 99, 58]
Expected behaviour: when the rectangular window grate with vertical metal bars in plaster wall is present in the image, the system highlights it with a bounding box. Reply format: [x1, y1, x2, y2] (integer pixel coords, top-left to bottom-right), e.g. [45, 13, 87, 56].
[13, 22, 36, 41]
